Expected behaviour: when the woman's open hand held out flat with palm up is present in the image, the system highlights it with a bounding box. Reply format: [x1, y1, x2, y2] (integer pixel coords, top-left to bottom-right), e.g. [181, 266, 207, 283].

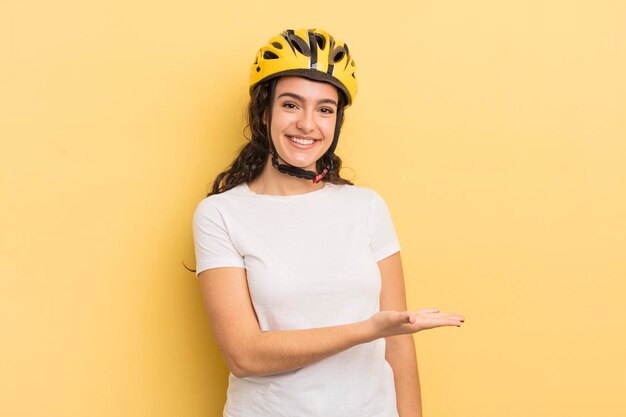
[370, 308, 465, 337]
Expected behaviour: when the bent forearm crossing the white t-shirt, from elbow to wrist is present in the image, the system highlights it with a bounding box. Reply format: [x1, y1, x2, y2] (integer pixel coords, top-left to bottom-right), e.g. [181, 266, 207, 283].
[229, 320, 377, 377]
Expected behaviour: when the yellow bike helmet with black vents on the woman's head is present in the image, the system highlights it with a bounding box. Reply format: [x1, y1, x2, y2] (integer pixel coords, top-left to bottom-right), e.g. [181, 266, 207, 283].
[250, 29, 357, 106]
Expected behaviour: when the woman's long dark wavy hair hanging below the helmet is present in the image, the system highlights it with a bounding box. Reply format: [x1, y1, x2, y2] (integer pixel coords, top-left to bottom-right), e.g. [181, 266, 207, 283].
[208, 79, 353, 196]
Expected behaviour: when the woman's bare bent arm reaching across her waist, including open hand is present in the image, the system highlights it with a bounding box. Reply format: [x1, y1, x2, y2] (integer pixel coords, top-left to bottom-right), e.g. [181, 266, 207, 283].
[198, 267, 463, 378]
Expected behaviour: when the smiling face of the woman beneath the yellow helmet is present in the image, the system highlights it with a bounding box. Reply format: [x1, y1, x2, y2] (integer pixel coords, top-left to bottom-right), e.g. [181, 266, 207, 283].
[271, 77, 339, 171]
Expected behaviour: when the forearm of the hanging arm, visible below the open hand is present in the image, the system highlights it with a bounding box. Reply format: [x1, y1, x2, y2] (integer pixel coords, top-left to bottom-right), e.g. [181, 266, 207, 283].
[385, 335, 422, 417]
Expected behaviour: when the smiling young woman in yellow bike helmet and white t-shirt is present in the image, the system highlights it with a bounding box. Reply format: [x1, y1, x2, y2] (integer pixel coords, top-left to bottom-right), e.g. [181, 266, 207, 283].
[193, 29, 464, 417]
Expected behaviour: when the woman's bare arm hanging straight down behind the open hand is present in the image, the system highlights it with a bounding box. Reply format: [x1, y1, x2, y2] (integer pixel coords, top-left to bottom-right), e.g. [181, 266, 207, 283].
[378, 252, 422, 417]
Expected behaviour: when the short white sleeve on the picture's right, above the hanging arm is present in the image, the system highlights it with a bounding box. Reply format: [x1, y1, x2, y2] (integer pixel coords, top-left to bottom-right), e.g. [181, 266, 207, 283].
[370, 192, 400, 262]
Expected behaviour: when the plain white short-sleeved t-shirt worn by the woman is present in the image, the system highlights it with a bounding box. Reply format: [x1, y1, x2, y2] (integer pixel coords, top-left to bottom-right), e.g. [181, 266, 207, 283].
[193, 183, 400, 417]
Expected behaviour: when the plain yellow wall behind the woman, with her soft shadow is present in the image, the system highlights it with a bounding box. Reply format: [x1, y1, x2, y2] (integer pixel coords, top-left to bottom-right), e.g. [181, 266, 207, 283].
[0, 0, 626, 417]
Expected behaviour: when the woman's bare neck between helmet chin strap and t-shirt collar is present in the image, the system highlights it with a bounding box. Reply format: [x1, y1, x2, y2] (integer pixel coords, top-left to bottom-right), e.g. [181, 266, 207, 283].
[248, 158, 324, 195]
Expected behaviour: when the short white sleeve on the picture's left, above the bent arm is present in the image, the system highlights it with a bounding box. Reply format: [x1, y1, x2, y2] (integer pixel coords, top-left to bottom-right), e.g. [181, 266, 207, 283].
[193, 199, 245, 276]
